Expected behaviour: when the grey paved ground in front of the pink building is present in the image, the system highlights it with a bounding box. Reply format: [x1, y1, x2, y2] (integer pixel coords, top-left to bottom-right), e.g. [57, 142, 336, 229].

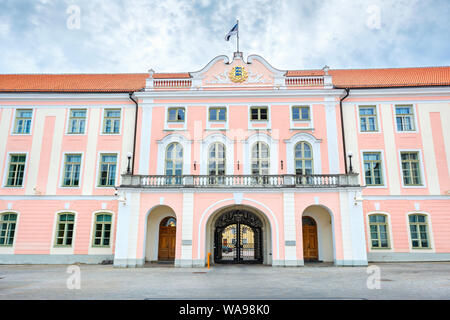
[0, 262, 450, 300]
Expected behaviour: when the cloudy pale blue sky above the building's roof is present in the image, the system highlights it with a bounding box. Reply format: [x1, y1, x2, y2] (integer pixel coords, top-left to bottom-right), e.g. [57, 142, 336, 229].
[0, 0, 450, 73]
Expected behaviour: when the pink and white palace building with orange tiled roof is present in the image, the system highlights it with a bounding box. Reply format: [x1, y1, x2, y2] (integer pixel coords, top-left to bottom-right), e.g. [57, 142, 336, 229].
[0, 53, 450, 267]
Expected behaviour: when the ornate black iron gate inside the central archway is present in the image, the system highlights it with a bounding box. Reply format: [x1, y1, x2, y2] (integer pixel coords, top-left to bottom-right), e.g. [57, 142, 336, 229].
[214, 210, 263, 263]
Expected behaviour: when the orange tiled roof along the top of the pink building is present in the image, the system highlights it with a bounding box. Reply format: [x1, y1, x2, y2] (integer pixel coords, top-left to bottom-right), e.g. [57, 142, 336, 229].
[0, 67, 450, 92]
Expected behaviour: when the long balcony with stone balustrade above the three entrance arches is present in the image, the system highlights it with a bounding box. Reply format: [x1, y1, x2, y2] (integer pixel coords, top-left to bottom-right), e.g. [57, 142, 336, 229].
[120, 173, 360, 188]
